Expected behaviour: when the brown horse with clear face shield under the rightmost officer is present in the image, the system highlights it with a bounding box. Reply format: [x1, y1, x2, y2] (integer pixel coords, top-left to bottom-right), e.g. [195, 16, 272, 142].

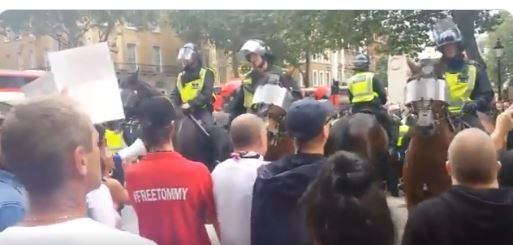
[403, 60, 494, 210]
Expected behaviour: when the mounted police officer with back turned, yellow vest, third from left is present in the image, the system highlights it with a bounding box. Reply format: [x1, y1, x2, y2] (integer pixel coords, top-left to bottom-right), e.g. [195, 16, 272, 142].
[348, 54, 397, 151]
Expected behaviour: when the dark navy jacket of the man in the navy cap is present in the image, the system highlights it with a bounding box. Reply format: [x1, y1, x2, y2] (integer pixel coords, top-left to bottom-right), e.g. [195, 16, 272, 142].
[251, 154, 325, 245]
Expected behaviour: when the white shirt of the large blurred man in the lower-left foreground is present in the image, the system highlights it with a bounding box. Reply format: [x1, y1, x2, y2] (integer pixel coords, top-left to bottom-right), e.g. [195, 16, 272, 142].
[0, 218, 156, 245]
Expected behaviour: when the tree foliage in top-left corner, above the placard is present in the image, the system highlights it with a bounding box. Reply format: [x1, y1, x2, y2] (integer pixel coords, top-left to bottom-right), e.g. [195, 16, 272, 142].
[0, 10, 158, 49]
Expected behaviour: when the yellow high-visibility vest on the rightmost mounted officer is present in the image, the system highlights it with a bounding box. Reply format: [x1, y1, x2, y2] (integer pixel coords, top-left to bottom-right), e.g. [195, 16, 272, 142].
[444, 64, 477, 113]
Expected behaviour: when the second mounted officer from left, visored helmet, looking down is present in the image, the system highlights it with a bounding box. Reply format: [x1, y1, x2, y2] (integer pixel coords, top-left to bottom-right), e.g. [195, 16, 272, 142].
[230, 39, 301, 122]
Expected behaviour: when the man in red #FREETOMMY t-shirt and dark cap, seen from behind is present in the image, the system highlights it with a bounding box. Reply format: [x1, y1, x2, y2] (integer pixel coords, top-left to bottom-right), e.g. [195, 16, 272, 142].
[126, 97, 217, 245]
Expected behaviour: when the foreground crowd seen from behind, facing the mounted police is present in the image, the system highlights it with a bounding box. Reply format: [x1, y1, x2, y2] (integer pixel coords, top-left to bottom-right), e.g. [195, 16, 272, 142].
[0, 92, 513, 245]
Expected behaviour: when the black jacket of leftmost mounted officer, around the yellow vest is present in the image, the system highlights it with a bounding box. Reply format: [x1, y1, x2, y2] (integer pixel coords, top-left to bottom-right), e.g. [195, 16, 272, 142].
[171, 65, 215, 110]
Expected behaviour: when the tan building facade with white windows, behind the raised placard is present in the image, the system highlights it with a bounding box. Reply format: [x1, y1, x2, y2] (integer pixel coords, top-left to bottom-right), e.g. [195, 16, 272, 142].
[0, 21, 227, 92]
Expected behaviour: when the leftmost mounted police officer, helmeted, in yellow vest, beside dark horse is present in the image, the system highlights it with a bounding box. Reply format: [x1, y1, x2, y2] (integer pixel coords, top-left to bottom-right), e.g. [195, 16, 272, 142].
[171, 43, 215, 128]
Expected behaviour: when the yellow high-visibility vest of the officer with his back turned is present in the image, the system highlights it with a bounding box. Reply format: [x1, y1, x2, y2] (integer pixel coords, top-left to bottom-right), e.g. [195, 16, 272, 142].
[348, 72, 378, 104]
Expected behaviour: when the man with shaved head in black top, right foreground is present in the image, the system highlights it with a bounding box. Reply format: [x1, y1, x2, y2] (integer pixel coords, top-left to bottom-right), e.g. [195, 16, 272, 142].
[403, 128, 513, 245]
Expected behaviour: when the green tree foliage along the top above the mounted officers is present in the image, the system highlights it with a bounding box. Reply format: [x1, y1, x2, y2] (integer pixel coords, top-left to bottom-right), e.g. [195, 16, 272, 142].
[170, 10, 498, 86]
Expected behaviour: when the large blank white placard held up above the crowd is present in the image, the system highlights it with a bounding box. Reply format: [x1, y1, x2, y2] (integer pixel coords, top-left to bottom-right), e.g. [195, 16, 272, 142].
[48, 42, 125, 123]
